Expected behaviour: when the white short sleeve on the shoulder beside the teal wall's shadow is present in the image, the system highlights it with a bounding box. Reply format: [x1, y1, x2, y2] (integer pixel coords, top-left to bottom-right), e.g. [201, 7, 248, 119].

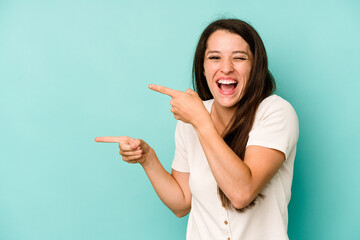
[247, 97, 299, 159]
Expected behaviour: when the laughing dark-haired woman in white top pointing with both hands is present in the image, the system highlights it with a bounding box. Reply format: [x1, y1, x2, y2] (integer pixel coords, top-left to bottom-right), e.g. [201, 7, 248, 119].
[96, 19, 298, 240]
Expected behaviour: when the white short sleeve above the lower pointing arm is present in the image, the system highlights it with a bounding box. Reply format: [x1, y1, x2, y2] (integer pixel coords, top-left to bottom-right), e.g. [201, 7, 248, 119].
[171, 121, 190, 172]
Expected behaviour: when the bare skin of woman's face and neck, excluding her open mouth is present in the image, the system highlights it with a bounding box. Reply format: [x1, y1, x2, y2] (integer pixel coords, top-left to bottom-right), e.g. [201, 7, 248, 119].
[204, 30, 253, 134]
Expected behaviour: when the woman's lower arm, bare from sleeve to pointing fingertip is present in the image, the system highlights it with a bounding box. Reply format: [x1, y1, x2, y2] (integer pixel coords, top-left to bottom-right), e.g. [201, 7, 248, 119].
[95, 137, 191, 217]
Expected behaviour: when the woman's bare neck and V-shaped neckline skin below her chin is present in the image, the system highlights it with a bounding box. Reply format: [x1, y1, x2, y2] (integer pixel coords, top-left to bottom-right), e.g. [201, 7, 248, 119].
[211, 102, 236, 135]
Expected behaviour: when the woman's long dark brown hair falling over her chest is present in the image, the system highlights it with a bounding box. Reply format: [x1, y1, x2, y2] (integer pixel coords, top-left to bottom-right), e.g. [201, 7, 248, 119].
[192, 19, 276, 212]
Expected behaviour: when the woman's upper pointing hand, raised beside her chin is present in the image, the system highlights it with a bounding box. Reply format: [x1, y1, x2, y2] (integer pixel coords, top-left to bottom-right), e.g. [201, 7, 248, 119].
[149, 84, 211, 128]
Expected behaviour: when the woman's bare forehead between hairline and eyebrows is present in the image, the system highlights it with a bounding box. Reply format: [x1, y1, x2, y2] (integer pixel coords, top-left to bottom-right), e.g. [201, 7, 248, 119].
[206, 30, 250, 52]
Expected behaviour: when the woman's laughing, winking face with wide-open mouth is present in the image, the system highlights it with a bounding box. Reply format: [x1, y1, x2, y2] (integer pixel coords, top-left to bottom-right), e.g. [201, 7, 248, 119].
[204, 30, 253, 108]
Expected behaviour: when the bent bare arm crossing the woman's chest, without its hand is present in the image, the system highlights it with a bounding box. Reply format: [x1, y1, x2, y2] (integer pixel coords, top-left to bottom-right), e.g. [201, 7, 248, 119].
[194, 122, 285, 209]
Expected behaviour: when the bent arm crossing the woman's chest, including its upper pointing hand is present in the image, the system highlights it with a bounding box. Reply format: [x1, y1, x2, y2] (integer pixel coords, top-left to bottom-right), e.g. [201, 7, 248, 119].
[149, 84, 285, 209]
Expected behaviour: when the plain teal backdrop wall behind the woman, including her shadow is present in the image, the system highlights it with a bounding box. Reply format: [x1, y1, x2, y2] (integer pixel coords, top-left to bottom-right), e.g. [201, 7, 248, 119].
[0, 0, 360, 240]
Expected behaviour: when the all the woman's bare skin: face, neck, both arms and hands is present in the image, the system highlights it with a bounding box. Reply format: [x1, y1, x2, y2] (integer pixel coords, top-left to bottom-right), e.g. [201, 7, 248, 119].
[95, 30, 285, 217]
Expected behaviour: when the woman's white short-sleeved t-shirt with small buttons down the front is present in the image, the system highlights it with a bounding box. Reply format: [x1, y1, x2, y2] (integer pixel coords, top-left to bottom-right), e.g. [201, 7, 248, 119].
[172, 95, 299, 240]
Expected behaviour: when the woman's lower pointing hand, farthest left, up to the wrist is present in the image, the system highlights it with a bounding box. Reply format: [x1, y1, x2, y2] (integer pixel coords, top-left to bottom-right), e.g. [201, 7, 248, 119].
[95, 136, 154, 166]
